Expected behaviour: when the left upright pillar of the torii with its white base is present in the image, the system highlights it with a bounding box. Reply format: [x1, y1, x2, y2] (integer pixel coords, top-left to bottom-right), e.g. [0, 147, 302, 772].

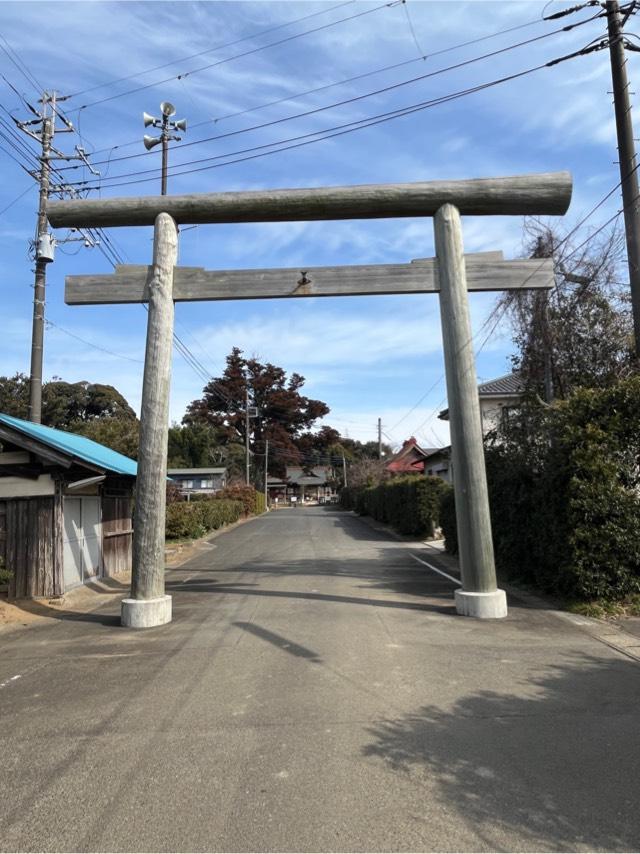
[122, 213, 178, 628]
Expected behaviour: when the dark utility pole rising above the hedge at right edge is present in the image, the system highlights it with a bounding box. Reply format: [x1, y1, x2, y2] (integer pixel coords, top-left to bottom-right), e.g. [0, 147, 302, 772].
[606, 0, 640, 358]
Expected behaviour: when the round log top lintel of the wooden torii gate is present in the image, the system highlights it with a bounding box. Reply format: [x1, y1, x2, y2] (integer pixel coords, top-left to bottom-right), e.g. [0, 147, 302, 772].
[48, 172, 572, 228]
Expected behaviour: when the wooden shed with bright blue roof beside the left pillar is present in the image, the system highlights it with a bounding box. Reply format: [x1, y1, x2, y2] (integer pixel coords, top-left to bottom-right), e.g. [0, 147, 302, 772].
[0, 414, 137, 598]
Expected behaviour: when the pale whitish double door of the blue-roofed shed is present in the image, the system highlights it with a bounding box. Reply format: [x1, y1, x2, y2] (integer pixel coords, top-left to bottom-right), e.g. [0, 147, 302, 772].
[64, 496, 102, 589]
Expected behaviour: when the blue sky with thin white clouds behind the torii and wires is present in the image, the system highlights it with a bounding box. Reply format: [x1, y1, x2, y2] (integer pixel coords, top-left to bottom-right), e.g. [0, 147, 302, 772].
[0, 0, 639, 446]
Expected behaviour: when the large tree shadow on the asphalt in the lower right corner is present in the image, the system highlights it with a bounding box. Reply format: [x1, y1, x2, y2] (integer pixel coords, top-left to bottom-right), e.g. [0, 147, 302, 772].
[363, 656, 640, 851]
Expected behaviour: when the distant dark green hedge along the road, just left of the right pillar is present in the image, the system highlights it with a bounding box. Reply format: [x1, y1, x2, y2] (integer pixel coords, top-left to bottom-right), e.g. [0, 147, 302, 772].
[340, 475, 450, 537]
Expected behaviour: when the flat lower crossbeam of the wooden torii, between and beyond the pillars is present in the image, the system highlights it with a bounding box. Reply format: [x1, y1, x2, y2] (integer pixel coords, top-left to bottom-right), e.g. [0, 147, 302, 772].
[65, 253, 553, 305]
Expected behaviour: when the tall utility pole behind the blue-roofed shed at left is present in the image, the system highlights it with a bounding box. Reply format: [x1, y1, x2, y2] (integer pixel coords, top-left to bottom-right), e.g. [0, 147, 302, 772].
[29, 92, 56, 424]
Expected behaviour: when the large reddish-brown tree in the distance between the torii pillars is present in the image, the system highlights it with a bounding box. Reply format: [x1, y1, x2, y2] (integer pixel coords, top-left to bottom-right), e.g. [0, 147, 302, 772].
[183, 347, 329, 482]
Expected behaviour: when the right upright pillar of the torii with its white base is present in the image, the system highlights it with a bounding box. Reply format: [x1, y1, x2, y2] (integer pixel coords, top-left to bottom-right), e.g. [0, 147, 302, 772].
[434, 204, 507, 617]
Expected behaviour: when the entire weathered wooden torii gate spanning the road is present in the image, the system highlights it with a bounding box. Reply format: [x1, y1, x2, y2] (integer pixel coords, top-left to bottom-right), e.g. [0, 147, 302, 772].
[48, 172, 572, 628]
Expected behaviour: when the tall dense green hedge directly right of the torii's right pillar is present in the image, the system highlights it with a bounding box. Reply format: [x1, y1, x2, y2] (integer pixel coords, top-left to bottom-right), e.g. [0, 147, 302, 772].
[441, 376, 640, 601]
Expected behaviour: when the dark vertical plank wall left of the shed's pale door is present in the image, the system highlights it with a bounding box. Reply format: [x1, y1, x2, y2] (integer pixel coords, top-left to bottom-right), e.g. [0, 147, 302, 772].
[5, 496, 56, 599]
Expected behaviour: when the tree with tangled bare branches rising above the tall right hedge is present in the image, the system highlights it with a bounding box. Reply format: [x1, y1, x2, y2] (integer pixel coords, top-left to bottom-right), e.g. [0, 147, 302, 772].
[501, 220, 633, 400]
